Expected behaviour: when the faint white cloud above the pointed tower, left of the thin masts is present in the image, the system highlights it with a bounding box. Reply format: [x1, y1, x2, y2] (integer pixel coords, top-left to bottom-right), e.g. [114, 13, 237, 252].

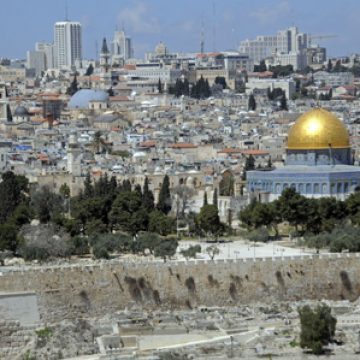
[118, 2, 161, 34]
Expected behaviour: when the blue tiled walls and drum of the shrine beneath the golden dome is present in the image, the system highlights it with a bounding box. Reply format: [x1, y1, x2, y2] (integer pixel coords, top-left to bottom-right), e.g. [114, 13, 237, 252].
[247, 148, 360, 201]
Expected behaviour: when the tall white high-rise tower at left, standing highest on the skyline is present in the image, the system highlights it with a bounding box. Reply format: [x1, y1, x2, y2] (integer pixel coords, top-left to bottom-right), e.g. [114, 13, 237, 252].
[54, 21, 82, 68]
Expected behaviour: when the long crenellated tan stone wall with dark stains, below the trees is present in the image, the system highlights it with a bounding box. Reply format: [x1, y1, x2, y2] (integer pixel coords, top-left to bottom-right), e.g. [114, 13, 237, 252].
[0, 254, 360, 322]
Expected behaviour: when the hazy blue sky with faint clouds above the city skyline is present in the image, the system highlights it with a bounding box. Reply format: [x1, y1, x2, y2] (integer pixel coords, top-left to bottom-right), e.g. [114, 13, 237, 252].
[0, 0, 360, 58]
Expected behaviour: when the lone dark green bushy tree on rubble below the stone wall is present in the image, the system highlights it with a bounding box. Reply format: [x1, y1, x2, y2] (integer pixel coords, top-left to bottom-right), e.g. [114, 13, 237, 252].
[298, 304, 336, 355]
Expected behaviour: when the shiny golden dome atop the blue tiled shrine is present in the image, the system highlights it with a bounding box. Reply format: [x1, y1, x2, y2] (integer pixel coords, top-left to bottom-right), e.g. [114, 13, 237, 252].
[287, 108, 350, 150]
